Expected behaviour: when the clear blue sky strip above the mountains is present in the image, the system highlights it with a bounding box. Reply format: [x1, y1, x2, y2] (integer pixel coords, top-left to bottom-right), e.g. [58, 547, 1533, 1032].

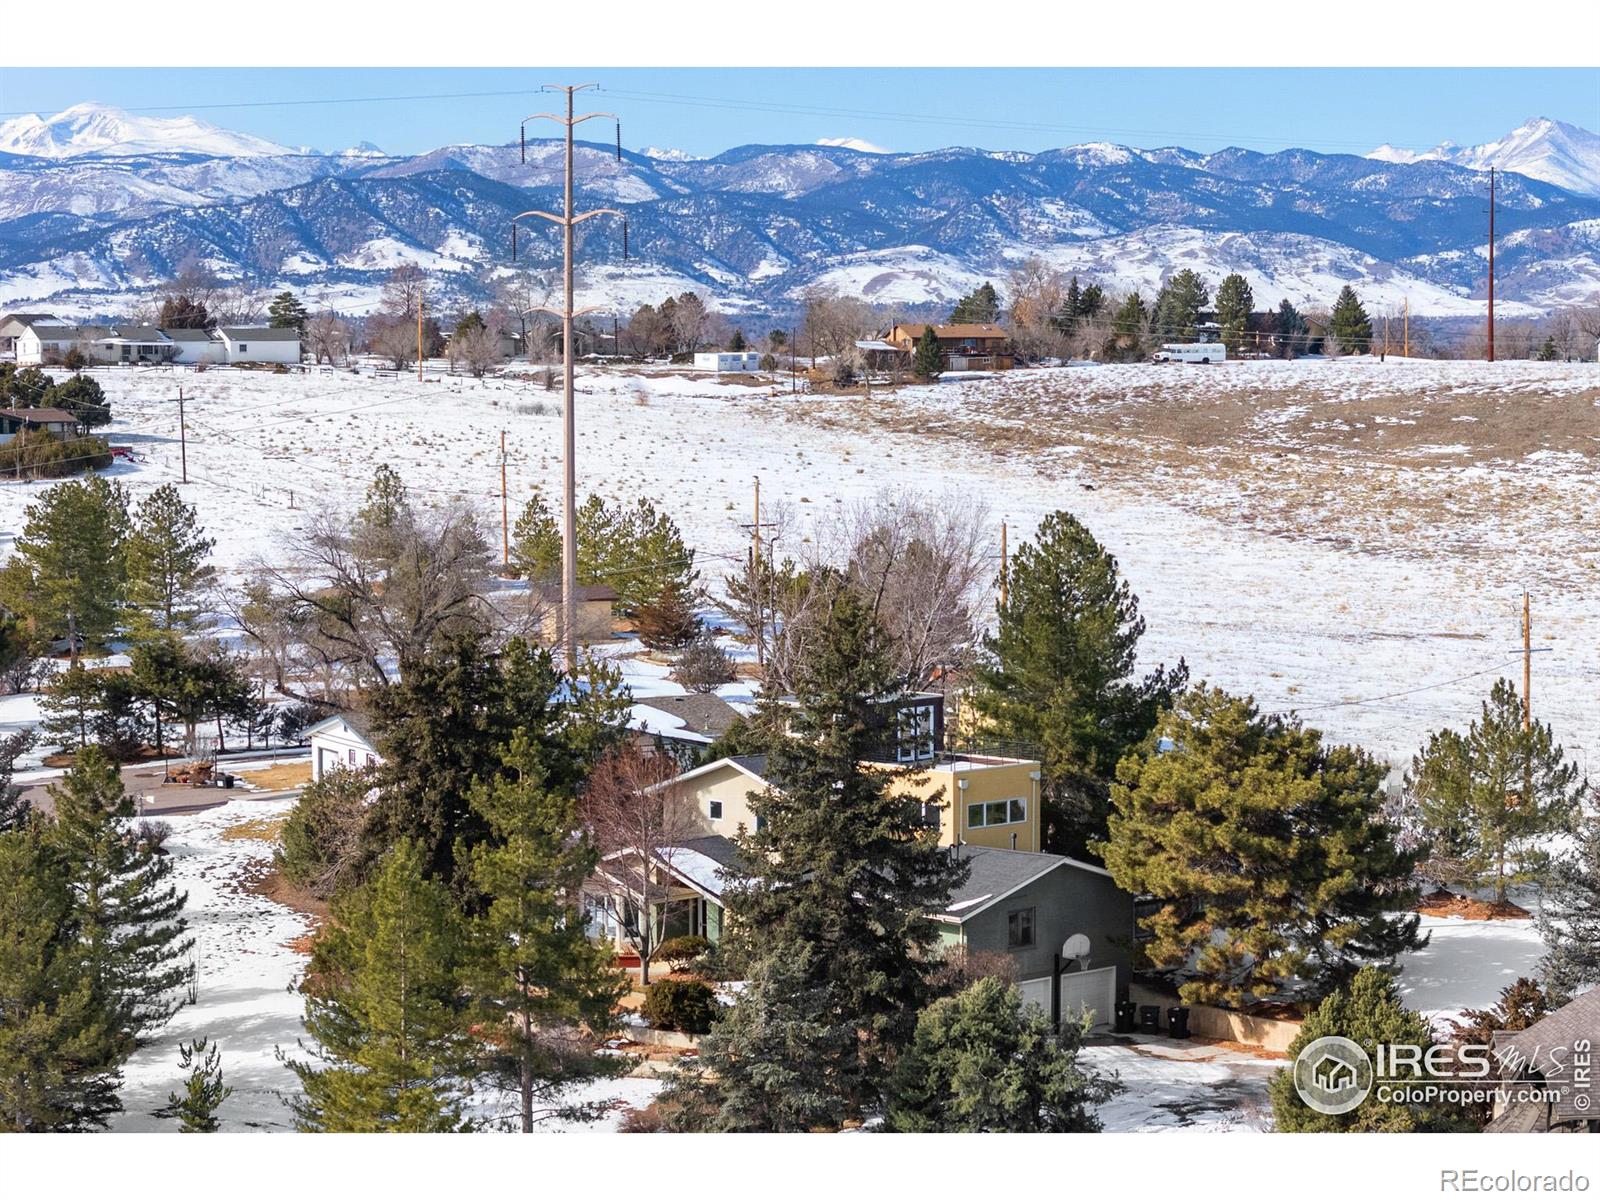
[0, 67, 1600, 154]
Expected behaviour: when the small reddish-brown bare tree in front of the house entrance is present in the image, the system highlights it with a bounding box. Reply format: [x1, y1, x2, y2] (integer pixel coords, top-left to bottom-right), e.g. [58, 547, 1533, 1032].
[579, 746, 704, 984]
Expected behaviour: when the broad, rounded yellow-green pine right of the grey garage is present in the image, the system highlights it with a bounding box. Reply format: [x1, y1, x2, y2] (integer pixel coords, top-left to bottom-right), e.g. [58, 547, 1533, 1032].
[1102, 686, 1426, 1006]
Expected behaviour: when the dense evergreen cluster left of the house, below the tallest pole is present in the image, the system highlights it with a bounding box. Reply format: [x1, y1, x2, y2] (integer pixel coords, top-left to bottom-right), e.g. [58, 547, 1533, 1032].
[283, 637, 627, 1131]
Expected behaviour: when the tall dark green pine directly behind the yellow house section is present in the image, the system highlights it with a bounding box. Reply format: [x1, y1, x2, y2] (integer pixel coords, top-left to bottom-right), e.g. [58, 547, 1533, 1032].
[973, 512, 1189, 853]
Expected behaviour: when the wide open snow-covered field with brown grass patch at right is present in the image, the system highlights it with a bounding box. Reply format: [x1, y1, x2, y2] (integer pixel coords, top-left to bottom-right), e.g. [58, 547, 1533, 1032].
[0, 360, 1600, 765]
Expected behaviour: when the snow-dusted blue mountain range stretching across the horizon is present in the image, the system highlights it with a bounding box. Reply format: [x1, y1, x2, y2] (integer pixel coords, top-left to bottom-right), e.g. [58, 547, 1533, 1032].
[0, 106, 1600, 315]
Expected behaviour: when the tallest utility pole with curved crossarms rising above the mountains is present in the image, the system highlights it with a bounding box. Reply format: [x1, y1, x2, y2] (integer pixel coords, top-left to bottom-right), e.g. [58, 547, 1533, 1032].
[510, 83, 627, 672]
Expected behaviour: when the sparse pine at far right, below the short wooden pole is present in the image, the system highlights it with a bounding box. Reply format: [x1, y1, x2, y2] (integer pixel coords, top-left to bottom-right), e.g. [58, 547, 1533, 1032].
[1406, 680, 1582, 902]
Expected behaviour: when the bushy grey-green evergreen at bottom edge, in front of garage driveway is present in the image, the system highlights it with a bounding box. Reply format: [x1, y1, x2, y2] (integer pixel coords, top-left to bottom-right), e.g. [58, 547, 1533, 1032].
[885, 978, 1117, 1133]
